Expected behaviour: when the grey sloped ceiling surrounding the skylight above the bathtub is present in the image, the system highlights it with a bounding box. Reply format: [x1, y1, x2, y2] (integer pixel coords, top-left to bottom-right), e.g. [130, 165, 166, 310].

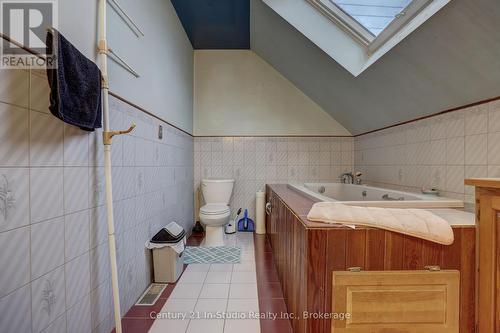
[250, 0, 500, 134]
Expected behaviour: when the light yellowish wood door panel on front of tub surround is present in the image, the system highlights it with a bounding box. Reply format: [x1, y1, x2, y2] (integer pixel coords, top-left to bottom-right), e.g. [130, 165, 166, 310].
[331, 270, 460, 333]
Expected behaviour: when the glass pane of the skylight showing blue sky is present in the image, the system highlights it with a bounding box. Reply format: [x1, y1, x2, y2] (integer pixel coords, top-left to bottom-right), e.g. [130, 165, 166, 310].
[329, 0, 412, 37]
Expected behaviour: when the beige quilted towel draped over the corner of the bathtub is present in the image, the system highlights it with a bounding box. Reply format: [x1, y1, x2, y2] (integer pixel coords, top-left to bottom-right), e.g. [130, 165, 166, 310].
[307, 202, 454, 245]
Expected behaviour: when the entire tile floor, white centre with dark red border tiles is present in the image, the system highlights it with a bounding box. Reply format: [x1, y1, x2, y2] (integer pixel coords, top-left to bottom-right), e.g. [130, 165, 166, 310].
[116, 233, 292, 333]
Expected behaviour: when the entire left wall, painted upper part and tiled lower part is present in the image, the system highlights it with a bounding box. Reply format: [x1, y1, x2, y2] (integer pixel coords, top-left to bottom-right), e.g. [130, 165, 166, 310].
[0, 0, 193, 333]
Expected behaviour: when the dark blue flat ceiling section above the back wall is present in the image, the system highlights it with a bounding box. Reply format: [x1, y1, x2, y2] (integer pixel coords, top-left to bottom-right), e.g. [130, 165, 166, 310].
[171, 0, 250, 49]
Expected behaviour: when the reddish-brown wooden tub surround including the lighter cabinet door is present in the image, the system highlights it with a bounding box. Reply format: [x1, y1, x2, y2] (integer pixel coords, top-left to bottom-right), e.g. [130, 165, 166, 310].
[266, 184, 474, 333]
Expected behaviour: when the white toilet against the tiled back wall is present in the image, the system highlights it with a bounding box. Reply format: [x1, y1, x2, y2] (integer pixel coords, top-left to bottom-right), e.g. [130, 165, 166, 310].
[199, 178, 234, 247]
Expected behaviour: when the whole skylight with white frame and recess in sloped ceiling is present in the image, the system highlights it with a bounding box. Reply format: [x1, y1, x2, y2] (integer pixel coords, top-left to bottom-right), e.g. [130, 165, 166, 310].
[262, 0, 451, 76]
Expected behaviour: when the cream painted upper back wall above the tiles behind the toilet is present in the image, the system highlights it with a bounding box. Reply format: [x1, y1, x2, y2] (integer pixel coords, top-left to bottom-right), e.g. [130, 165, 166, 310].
[194, 50, 350, 136]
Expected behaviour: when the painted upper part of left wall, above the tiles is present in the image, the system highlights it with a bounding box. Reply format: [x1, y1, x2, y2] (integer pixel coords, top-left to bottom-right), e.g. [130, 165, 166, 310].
[58, 0, 193, 133]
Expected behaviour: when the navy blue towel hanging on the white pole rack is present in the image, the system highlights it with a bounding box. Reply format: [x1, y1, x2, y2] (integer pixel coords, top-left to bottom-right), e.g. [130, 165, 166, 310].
[47, 29, 102, 131]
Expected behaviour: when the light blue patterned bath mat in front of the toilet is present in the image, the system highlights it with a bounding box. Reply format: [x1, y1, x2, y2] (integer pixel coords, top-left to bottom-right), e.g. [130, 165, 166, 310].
[183, 246, 241, 264]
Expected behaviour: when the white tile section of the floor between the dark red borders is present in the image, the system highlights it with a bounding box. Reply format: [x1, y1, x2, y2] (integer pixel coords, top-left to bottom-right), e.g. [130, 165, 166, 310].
[149, 233, 260, 333]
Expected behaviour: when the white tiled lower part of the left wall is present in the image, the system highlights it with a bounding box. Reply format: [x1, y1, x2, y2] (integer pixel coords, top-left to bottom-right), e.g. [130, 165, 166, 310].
[0, 70, 193, 333]
